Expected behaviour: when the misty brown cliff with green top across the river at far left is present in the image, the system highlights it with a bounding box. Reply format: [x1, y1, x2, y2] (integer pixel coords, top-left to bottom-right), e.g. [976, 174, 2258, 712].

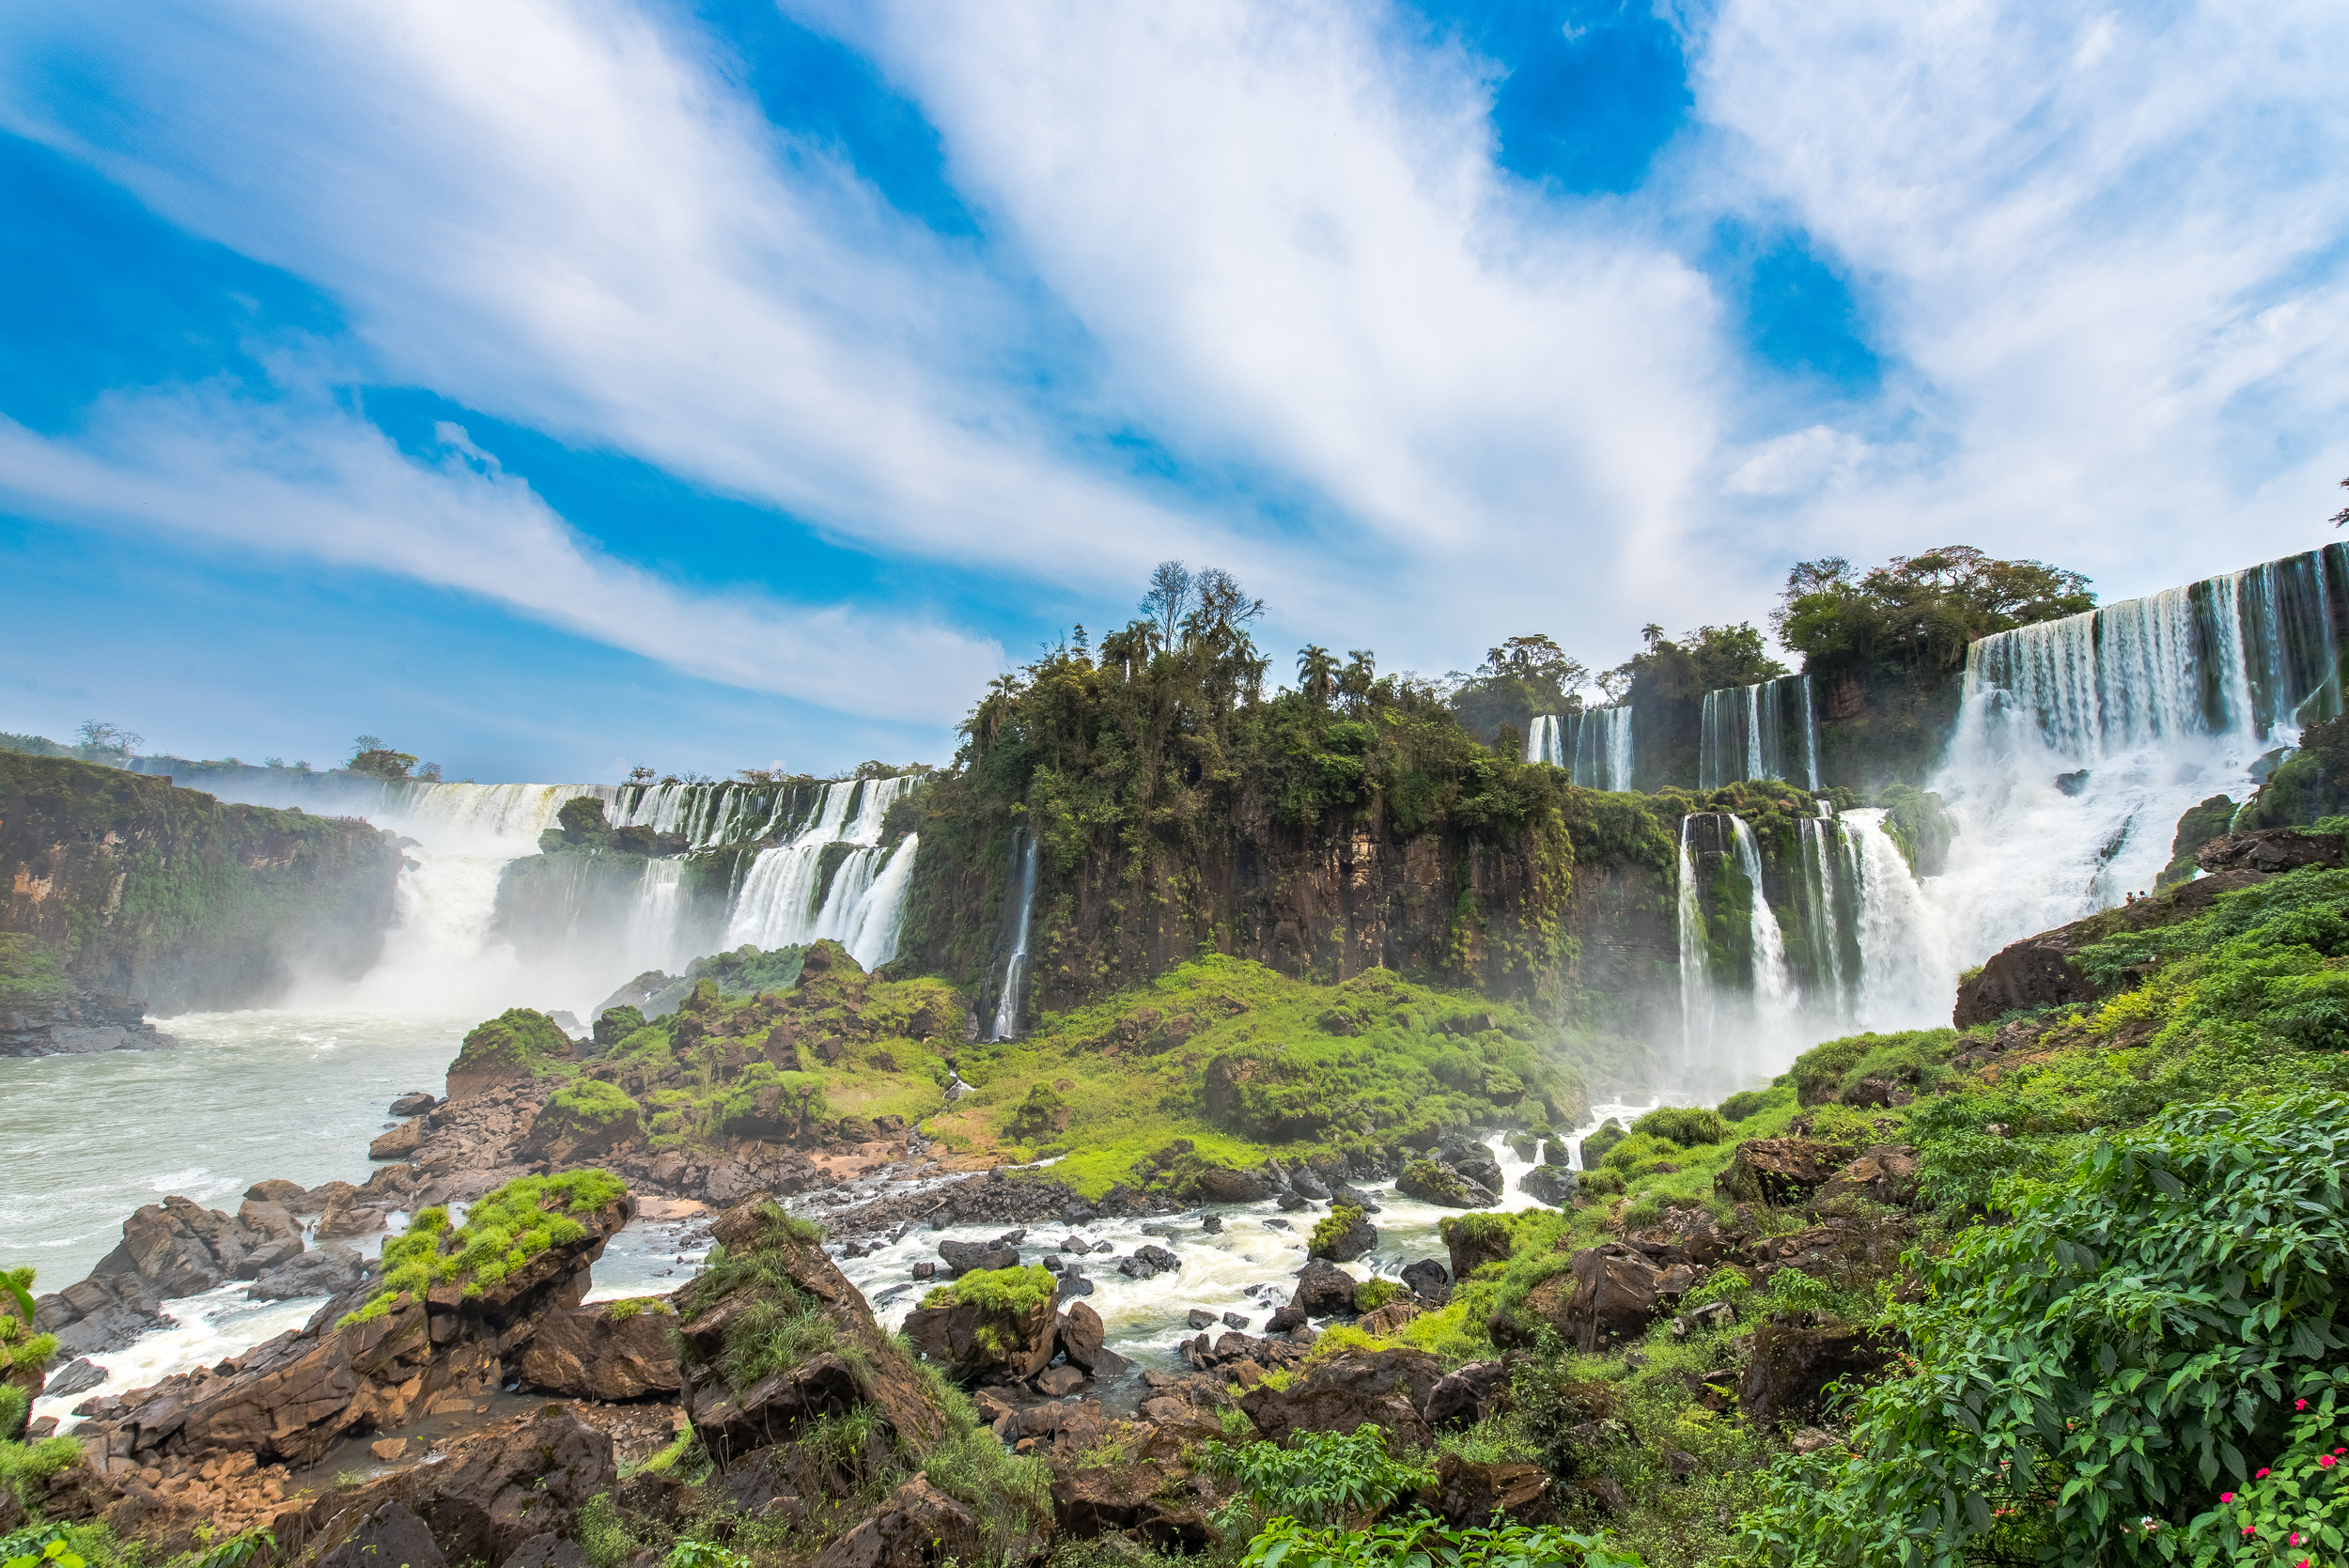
[0, 753, 399, 1014]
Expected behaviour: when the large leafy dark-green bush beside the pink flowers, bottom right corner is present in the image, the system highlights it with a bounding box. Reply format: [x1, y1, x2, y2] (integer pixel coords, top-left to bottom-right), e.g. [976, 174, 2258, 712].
[1748, 1094, 2349, 1563]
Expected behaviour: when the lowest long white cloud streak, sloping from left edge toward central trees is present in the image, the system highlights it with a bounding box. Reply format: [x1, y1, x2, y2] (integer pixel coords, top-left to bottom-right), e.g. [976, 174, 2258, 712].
[0, 395, 1003, 723]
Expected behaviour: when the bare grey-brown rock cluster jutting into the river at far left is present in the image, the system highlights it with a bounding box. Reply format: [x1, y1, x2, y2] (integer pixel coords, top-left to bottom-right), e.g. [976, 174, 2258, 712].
[33, 1197, 303, 1357]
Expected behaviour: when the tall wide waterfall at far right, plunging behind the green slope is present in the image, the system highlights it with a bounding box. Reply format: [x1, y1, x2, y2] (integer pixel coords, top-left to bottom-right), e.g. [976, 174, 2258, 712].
[1934, 545, 2349, 981]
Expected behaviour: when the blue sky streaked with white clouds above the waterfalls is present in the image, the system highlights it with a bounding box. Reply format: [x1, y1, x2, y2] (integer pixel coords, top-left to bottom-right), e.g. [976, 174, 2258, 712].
[0, 0, 2349, 782]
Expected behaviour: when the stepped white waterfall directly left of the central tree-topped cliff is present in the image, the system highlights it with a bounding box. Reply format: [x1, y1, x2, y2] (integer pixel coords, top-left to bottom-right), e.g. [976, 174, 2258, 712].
[726, 775, 921, 962]
